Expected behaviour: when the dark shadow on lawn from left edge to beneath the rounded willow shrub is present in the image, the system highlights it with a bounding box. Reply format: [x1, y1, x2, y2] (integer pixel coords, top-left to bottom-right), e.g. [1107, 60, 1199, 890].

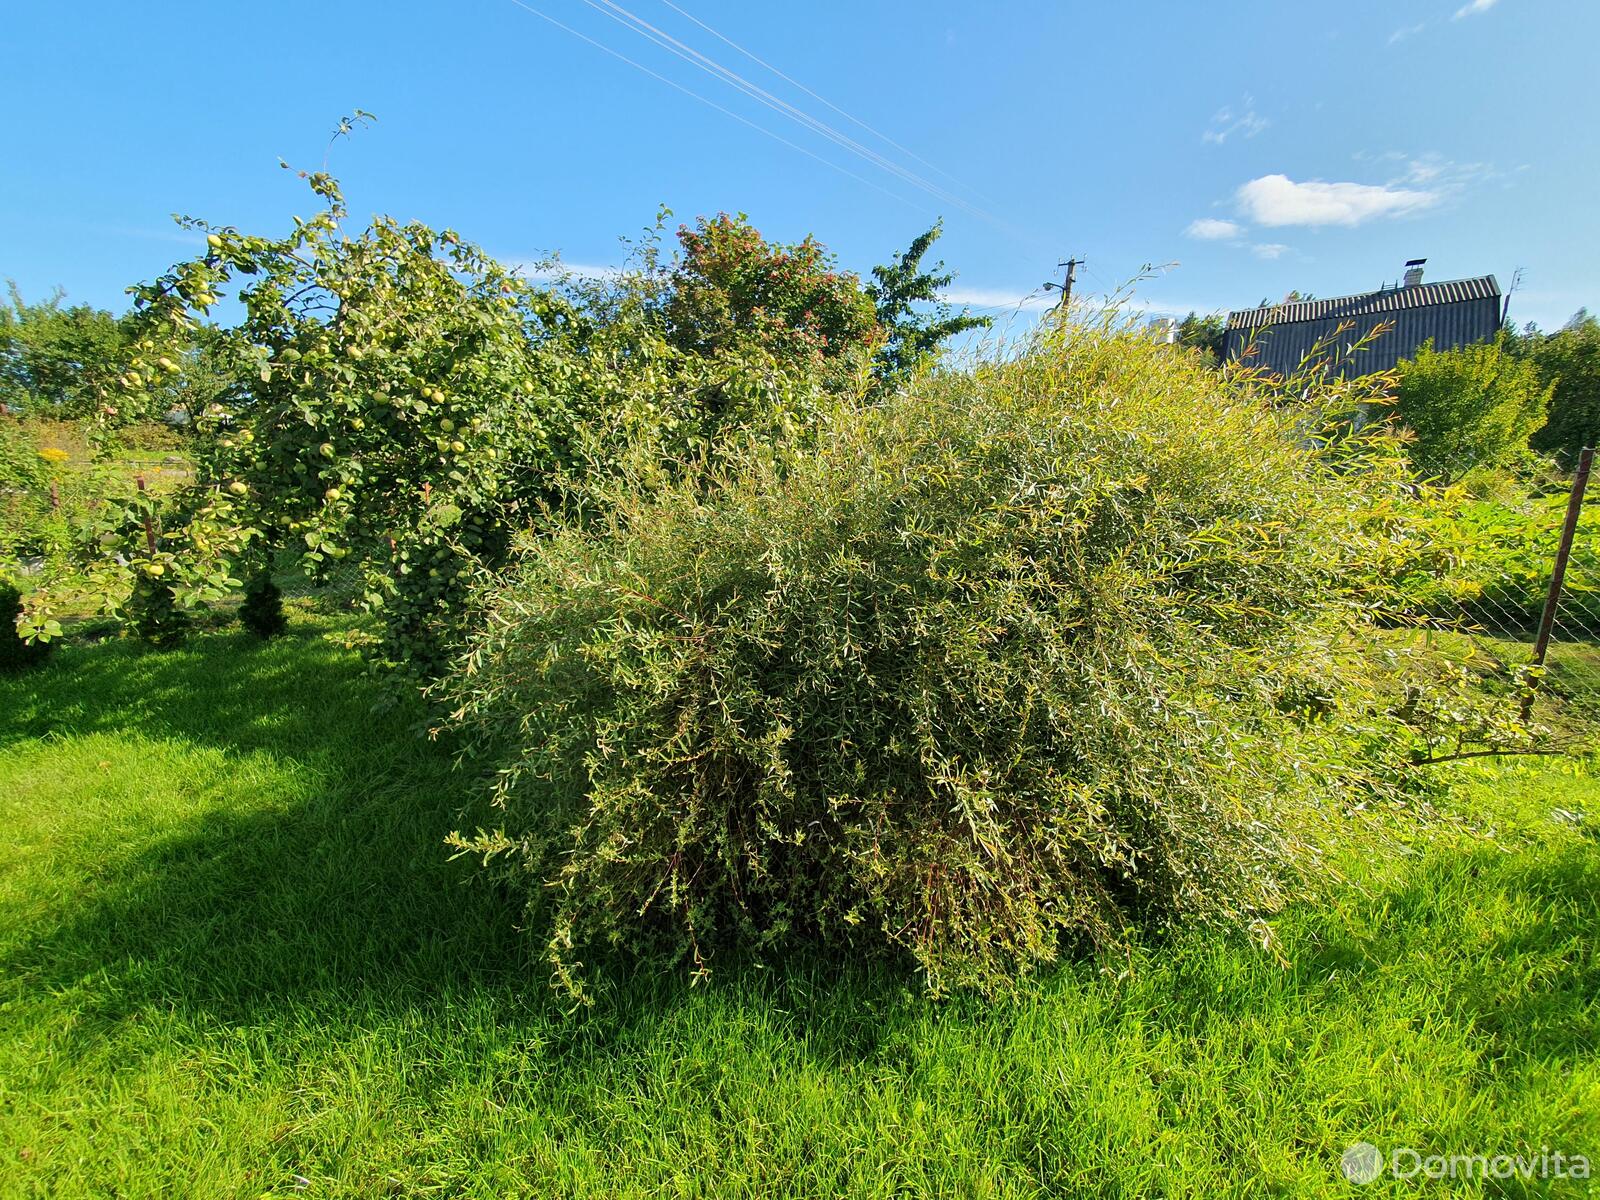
[0, 627, 934, 1059]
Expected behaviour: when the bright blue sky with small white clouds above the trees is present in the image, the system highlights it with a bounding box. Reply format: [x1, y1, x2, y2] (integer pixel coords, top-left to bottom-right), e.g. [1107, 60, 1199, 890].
[0, 0, 1600, 326]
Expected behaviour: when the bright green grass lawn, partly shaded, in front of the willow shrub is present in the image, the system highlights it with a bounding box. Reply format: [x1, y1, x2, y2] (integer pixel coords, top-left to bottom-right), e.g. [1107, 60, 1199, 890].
[0, 619, 1600, 1198]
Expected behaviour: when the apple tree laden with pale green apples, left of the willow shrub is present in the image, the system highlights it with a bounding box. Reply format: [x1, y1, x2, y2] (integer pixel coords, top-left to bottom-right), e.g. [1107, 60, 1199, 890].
[18, 174, 601, 675]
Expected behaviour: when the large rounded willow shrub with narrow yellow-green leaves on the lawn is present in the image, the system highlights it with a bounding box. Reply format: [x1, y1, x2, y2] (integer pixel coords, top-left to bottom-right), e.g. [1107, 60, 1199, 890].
[446, 330, 1392, 990]
